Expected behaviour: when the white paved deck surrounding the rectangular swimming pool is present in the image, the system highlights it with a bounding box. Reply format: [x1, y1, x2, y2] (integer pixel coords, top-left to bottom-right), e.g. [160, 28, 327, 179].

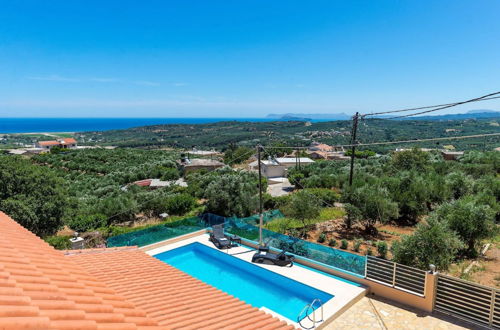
[144, 234, 367, 329]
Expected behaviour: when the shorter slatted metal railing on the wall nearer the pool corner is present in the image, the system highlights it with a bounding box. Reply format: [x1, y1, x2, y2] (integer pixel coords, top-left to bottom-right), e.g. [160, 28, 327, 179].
[366, 256, 427, 296]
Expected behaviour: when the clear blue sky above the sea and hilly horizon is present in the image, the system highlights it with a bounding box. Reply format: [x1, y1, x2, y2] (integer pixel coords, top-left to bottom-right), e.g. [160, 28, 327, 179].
[0, 0, 500, 117]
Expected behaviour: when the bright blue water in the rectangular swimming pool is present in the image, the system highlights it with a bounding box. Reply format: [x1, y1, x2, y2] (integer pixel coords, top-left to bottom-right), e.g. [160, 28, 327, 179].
[154, 243, 333, 321]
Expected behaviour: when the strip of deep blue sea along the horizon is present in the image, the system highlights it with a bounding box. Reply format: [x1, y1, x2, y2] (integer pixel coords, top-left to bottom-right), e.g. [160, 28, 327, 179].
[0, 118, 304, 133]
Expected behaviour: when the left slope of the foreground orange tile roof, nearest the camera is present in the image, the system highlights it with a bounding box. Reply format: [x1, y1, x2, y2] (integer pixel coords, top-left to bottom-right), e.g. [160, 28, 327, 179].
[0, 212, 163, 330]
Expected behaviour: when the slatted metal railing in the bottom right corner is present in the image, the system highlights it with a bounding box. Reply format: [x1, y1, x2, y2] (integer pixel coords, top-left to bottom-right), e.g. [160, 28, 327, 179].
[434, 274, 500, 329]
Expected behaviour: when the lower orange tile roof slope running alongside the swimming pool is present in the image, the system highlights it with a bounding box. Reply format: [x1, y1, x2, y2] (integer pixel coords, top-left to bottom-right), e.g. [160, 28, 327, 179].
[67, 248, 293, 329]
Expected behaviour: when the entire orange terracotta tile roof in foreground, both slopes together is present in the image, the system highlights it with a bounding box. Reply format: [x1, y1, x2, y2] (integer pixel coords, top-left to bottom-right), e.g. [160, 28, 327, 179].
[0, 212, 293, 330]
